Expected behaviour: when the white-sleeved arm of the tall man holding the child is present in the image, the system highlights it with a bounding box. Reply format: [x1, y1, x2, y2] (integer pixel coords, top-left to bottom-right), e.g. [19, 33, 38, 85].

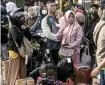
[41, 18, 57, 41]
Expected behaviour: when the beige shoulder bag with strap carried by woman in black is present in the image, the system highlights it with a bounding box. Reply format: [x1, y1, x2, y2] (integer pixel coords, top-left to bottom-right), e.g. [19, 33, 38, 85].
[10, 30, 33, 58]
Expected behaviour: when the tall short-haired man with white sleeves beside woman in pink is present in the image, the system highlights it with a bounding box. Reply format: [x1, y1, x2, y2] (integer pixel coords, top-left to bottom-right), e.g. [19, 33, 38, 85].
[41, 0, 60, 64]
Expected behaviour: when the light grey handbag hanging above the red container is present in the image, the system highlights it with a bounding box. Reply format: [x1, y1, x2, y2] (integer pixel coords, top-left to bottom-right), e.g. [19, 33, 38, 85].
[81, 42, 92, 67]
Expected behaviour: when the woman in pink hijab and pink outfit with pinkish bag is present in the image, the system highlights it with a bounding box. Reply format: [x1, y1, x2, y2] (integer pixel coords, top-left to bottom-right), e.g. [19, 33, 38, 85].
[56, 10, 83, 65]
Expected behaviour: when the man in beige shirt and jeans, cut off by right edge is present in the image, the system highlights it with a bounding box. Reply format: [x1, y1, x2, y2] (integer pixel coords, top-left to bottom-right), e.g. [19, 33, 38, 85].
[91, 4, 105, 85]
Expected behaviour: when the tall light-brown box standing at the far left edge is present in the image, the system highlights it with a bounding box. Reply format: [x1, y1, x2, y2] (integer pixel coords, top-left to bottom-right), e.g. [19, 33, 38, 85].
[1, 60, 9, 85]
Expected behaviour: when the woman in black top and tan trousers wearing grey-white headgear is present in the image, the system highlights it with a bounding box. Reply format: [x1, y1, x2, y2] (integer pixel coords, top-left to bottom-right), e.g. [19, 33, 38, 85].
[8, 8, 31, 85]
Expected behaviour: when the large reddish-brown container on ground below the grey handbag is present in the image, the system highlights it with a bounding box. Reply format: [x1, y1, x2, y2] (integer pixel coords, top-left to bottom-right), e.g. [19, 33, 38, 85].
[74, 65, 92, 84]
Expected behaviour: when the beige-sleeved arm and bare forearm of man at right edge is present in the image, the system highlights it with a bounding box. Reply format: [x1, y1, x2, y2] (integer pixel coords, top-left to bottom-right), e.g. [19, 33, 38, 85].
[91, 26, 105, 77]
